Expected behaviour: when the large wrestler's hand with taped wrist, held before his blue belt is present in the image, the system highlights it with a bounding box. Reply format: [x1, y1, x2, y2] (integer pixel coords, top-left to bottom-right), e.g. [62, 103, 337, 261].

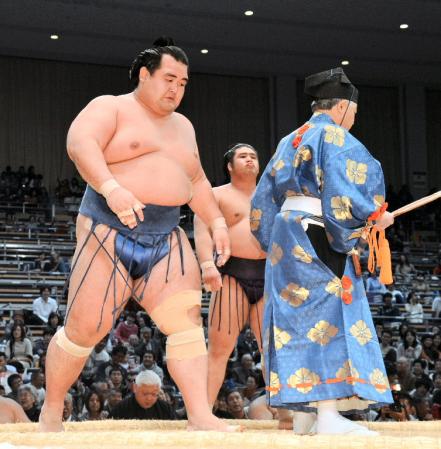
[107, 186, 145, 229]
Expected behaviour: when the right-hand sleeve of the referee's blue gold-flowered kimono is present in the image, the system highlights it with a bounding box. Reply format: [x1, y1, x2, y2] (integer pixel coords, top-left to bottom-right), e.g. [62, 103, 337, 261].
[322, 135, 385, 253]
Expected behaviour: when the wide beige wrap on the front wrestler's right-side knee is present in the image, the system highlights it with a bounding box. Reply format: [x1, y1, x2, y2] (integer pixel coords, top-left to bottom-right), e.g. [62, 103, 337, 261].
[150, 290, 207, 360]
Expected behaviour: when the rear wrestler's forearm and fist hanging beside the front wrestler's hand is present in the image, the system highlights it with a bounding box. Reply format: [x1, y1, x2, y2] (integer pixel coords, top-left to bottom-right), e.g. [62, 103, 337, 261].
[193, 192, 222, 291]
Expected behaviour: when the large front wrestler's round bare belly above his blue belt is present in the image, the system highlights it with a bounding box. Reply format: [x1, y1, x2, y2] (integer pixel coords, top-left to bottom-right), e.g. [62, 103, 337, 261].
[108, 152, 192, 206]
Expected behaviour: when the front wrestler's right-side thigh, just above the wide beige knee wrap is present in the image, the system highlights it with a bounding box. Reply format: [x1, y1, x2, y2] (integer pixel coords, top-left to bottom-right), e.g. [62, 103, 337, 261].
[134, 228, 201, 313]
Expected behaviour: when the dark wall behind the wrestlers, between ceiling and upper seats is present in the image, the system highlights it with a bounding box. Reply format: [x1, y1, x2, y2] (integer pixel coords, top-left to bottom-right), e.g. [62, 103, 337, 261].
[0, 57, 441, 194]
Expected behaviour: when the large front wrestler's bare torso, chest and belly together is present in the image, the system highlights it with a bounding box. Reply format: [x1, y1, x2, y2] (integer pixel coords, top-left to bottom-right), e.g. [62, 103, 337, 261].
[104, 103, 200, 206]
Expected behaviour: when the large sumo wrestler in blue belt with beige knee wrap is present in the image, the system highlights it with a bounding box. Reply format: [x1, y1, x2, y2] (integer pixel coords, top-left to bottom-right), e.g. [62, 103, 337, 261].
[40, 40, 233, 431]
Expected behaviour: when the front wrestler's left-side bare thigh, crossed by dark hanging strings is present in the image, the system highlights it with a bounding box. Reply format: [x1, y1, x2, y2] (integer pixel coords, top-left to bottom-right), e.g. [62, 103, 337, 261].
[65, 215, 131, 345]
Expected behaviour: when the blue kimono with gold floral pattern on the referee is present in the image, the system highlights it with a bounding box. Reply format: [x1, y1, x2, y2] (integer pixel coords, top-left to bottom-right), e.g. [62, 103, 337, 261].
[251, 113, 392, 410]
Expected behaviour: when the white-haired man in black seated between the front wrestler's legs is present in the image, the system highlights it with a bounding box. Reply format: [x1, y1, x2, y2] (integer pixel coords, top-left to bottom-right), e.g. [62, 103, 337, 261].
[109, 370, 176, 419]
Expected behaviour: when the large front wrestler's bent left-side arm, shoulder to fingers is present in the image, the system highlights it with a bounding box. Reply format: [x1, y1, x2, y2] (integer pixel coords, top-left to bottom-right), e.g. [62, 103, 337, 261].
[67, 95, 144, 228]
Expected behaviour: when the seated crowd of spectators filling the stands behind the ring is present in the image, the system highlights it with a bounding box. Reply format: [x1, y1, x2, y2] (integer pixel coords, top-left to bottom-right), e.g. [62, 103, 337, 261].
[0, 182, 441, 422]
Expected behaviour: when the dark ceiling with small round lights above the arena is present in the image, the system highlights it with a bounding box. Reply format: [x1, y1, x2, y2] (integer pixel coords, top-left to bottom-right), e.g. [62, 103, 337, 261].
[0, 0, 441, 86]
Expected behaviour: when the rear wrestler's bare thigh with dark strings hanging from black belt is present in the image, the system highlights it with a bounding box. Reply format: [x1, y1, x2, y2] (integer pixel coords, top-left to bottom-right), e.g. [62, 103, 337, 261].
[208, 275, 249, 336]
